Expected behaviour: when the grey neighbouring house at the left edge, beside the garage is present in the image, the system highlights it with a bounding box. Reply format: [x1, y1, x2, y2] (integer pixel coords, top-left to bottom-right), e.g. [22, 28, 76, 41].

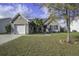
[0, 18, 11, 33]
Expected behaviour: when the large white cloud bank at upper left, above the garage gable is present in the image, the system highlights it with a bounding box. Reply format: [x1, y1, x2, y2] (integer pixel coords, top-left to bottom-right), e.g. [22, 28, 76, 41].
[0, 4, 32, 17]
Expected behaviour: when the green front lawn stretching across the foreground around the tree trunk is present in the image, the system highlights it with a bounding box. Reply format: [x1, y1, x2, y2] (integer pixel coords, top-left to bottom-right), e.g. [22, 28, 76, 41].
[0, 33, 79, 56]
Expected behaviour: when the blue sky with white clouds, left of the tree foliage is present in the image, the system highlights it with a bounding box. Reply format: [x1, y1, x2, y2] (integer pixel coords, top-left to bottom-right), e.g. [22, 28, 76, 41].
[0, 3, 48, 18]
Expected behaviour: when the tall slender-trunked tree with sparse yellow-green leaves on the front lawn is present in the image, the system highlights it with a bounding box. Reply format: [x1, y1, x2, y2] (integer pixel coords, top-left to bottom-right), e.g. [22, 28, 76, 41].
[41, 3, 78, 43]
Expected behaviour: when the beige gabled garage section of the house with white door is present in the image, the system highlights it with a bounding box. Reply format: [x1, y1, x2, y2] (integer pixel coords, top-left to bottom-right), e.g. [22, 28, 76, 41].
[11, 13, 30, 34]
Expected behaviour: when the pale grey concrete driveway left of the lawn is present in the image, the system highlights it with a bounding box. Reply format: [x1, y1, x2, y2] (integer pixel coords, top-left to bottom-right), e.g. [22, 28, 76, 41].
[0, 34, 21, 45]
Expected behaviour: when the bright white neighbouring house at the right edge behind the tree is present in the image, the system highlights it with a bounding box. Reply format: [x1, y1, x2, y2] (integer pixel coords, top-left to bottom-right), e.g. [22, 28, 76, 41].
[70, 16, 79, 32]
